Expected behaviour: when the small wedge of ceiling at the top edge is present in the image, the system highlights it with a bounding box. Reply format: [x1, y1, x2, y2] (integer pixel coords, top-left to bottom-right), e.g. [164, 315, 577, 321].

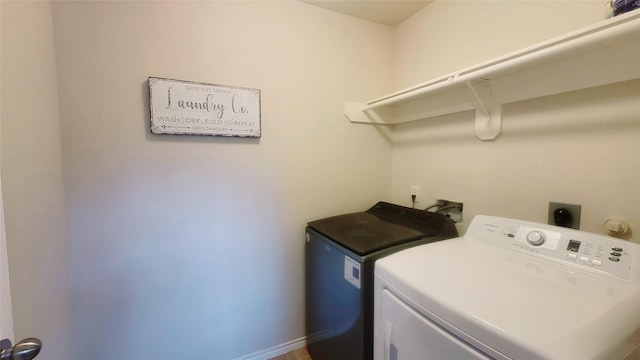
[300, 0, 433, 26]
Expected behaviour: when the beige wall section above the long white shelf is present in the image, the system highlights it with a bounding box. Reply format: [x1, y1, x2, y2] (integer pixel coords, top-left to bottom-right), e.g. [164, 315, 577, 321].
[393, 0, 605, 89]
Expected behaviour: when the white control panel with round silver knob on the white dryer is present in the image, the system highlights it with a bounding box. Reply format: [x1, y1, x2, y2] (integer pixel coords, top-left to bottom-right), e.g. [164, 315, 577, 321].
[465, 215, 640, 283]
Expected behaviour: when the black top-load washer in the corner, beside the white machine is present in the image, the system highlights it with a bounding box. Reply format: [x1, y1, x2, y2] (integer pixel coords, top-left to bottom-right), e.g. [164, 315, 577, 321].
[305, 202, 458, 360]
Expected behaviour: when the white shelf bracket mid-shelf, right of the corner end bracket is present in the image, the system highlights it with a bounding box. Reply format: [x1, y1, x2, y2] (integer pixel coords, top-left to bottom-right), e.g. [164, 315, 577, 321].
[466, 79, 502, 141]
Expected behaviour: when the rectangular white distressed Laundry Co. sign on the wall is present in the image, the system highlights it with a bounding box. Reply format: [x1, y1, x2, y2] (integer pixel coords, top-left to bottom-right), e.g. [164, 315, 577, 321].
[149, 77, 260, 138]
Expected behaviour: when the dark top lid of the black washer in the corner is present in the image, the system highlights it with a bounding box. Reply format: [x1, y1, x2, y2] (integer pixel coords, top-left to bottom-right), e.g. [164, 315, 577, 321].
[309, 202, 457, 256]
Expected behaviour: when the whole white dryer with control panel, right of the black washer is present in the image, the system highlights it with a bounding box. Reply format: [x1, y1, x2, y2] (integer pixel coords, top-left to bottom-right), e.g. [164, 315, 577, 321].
[374, 216, 640, 360]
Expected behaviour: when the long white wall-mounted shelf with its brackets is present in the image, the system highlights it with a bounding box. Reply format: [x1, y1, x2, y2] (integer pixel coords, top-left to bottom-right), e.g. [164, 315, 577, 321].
[345, 10, 640, 140]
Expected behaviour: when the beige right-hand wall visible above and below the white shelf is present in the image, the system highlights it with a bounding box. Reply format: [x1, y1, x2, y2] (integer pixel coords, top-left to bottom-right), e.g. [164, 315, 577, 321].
[391, 1, 640, 241]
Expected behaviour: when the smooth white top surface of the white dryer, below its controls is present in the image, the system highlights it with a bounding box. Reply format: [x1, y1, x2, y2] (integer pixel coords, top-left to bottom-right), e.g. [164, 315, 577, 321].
[375, 238, 640, 359]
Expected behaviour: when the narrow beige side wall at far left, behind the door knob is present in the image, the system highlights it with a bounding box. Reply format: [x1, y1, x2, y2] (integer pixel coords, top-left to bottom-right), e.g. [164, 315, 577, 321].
[0, 1, 71, 360]
